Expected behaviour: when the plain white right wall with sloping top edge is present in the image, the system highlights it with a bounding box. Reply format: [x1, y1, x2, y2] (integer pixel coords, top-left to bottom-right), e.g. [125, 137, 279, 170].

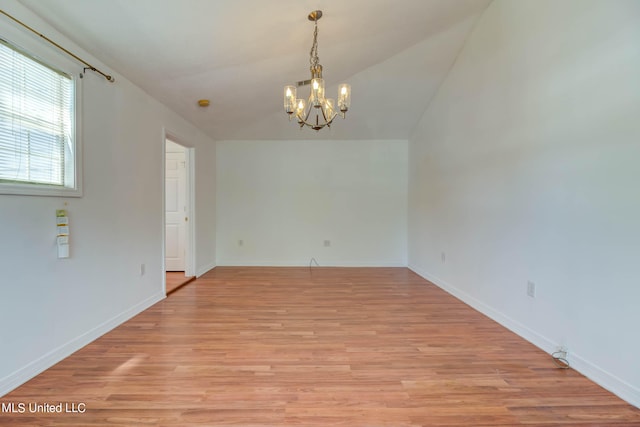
[409, 0, 640, 406]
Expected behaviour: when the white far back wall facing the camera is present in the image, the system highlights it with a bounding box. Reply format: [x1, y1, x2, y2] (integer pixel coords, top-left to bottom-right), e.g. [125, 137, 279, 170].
[216, 141, 407, 266]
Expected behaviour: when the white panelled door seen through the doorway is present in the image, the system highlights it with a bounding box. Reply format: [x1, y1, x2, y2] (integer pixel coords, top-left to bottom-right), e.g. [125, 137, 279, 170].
[165, 144, 188, 271]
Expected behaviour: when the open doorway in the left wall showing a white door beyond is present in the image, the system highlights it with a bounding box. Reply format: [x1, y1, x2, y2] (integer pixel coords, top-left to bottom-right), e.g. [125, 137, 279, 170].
[164, 137, 193, 295]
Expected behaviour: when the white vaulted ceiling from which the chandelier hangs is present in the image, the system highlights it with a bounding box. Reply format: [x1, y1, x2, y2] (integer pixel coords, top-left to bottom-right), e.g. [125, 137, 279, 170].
[21, 0, 490, 140]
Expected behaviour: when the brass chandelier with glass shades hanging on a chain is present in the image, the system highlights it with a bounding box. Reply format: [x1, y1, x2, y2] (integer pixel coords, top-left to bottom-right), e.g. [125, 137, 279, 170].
[284, 10, 351, 131]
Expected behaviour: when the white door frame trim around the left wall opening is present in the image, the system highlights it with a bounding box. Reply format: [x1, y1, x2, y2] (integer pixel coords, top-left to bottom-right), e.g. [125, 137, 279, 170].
[161, 127, 196, 295]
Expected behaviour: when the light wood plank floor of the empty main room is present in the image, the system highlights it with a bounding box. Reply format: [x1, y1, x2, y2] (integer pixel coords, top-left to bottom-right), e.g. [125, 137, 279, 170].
[0, 267, 640, 427]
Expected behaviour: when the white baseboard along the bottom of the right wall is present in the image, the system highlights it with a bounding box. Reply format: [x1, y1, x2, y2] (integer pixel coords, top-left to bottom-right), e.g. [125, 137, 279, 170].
[409, 265, 640, 408]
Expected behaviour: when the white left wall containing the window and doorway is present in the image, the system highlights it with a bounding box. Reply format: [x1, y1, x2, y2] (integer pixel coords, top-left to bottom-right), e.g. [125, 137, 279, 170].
[0, 1, 215, 395]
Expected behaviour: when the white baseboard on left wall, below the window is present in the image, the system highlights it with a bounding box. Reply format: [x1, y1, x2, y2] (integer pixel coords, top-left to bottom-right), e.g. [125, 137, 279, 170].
[0, 293, 166, 397]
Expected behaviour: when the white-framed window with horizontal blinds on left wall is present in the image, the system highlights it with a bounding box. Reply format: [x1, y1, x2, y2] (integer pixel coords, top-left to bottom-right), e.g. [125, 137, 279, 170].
[0, 39, 81, 196]
